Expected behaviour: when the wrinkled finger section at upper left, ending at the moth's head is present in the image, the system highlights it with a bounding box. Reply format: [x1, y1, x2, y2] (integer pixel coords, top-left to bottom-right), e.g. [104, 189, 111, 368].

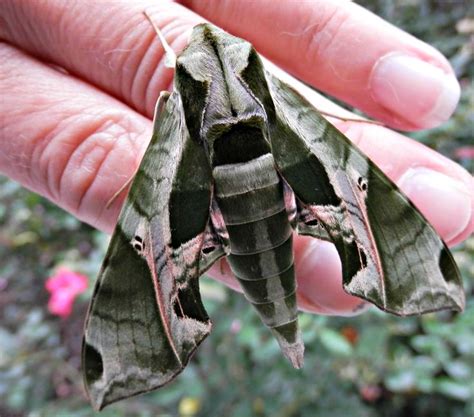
[0, 0, 202, 118]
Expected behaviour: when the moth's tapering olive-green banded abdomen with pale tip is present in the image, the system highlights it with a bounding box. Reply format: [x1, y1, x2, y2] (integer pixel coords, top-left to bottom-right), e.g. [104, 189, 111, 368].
[214, 154, 303, 367]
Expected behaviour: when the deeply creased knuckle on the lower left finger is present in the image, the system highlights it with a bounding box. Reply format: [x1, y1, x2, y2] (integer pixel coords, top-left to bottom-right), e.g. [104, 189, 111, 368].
[37, 112, 140, 221]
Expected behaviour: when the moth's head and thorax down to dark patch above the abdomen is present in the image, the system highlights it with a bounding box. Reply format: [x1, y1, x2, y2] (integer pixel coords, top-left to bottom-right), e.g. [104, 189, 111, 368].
[176, 25, 269, 165]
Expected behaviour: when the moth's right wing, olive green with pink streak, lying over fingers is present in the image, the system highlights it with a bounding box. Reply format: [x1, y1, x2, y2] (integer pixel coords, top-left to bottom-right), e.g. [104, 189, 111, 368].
[267, 74, 464, 315]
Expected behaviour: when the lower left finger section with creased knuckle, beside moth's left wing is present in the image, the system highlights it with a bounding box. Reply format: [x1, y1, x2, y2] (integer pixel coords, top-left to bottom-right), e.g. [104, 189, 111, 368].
[0, 43, 151, 233]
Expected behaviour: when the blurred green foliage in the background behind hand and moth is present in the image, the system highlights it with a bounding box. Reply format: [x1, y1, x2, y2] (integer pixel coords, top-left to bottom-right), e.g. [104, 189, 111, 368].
[0, 0, 474, 417]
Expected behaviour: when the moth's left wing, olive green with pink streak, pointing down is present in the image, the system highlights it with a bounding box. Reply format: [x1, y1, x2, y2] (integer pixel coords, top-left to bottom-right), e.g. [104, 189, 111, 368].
[83, 93, 216, 409]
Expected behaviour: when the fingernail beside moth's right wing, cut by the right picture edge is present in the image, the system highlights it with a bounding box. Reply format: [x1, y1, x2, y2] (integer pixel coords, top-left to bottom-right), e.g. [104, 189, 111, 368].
[398, 167, 471, 242]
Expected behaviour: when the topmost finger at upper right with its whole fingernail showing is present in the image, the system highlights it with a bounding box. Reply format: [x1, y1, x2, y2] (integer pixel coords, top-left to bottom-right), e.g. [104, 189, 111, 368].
[181, 0, 460, 129]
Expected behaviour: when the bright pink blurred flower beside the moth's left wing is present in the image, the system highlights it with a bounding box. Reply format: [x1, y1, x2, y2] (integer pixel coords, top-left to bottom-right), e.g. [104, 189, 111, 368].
[45, 267, 88, 317]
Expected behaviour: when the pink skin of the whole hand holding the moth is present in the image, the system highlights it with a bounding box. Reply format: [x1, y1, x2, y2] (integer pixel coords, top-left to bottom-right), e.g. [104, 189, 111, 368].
[0, 0, 474, 315]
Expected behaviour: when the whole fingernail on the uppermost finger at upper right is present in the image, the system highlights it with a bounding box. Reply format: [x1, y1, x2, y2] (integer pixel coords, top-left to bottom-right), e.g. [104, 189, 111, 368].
[370, 53, 461, 128]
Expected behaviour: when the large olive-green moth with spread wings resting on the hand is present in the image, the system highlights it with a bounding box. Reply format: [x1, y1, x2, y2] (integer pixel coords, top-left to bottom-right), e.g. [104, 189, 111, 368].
[83, 17, 464, 409]
